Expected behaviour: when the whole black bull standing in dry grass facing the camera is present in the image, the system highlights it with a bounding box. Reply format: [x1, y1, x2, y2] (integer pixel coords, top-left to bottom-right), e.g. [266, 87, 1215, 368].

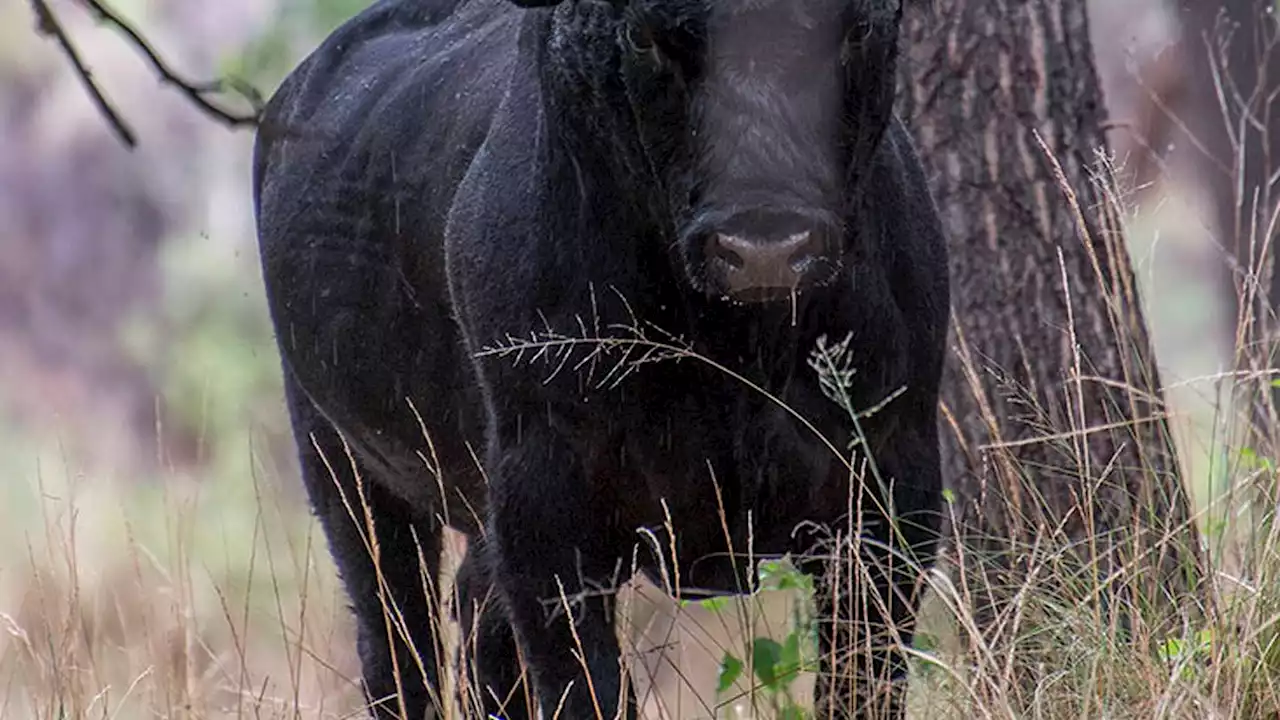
[253, 0, 948, 720]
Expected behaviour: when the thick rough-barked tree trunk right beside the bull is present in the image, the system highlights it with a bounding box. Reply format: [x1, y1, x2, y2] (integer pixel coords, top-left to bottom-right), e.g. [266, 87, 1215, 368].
[901, 0, 1199, 633]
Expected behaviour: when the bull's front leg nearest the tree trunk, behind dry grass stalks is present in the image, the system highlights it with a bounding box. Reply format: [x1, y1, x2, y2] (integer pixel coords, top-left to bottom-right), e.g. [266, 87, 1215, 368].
[809, 412, 941, 720]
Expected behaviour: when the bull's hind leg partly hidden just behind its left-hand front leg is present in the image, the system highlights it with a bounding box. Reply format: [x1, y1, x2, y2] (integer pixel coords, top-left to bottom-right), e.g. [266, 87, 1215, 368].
[457, 538, 534, 720]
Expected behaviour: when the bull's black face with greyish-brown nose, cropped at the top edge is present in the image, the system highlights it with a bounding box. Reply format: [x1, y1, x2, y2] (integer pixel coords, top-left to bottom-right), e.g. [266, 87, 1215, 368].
[617, 0, 901, 302]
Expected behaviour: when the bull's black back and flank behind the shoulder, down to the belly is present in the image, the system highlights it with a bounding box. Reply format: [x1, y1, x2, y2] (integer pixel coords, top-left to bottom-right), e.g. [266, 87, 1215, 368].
[253, 0, 518, 515]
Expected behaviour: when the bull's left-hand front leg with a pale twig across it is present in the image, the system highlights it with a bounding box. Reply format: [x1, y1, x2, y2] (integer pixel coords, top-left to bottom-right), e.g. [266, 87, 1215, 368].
[489, 427, 635, 720]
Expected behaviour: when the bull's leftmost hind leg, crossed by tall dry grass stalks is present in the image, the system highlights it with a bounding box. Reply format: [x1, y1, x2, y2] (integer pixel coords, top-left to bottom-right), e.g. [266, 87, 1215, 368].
[285, 380, 443, 720]
